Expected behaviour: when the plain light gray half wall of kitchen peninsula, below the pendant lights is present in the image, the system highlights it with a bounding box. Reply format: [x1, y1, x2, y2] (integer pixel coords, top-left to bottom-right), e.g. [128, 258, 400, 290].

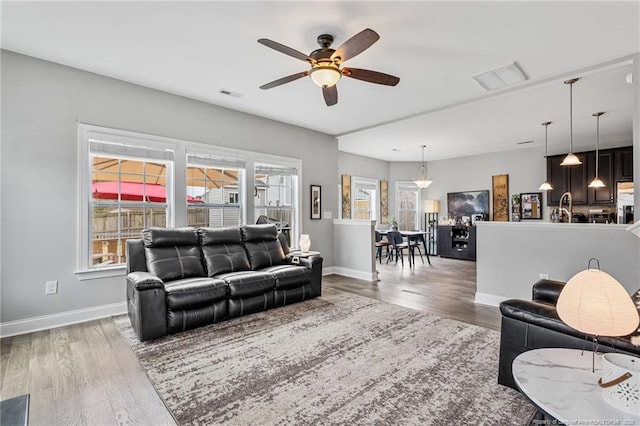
[475, 220, 640, 306]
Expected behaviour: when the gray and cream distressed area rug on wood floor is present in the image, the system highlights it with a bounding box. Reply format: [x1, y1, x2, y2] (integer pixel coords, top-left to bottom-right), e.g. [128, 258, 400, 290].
[116, 289, 534, 425]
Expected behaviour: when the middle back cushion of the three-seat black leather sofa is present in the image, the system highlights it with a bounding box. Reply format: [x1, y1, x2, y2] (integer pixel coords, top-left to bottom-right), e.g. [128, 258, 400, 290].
[198, 226, 251, 277]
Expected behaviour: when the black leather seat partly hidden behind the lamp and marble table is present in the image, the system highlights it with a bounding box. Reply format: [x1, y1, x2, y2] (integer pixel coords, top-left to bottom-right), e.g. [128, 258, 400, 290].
[498, 280, 640, 389]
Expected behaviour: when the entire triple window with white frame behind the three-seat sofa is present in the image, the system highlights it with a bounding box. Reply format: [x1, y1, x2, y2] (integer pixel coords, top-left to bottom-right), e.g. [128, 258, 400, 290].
[77, 124, 301, 280]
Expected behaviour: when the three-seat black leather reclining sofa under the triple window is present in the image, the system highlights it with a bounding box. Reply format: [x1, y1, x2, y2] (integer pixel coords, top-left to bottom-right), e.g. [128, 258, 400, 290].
[126, 224, 322, 341]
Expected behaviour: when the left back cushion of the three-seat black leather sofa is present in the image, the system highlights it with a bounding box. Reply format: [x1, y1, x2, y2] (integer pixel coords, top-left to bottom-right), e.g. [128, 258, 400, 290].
[142, 228, 206, 282]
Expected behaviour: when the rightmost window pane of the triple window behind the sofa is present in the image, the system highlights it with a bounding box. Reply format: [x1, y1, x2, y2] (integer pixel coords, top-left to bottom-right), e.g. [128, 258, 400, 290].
[254, 163, 299, 250]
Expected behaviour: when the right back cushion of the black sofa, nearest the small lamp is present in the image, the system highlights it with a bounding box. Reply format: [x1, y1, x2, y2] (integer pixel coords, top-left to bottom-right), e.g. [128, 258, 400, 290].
[242, 224, 285, 271]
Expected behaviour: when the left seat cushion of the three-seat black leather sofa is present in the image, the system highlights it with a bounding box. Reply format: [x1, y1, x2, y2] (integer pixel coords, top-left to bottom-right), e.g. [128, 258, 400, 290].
[164, 278, 228, 311]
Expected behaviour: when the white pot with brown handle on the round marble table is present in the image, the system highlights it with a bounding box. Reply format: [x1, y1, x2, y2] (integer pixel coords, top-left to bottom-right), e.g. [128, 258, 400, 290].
[598, 353, 640, 415]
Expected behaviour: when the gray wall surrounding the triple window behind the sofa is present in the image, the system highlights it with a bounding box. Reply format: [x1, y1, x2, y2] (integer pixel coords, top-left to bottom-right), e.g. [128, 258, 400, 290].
[0, 51, 338, 323]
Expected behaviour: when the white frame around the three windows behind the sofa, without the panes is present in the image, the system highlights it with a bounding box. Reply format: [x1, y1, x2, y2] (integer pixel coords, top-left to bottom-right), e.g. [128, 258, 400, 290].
[76, 123, 303, 281]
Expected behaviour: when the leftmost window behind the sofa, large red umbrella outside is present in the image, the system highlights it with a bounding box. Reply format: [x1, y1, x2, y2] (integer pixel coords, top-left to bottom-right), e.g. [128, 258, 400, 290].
[81, 138, 173, 269]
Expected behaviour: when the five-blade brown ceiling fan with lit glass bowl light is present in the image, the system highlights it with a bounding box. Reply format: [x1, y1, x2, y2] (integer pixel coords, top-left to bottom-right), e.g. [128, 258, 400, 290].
[258, 28, 400, 106]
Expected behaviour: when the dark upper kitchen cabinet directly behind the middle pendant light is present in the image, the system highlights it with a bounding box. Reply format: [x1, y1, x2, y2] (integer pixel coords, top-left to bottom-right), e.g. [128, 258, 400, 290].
[547, 153, 589, 206]
